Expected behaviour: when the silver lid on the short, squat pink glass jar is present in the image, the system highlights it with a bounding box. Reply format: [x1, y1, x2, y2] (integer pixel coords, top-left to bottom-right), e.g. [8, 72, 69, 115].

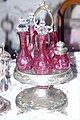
[54, 41, 67, 55]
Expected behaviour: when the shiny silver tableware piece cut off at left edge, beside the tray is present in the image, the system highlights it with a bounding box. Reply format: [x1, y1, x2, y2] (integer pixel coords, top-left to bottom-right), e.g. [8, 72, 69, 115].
[0, 51, 11, 92]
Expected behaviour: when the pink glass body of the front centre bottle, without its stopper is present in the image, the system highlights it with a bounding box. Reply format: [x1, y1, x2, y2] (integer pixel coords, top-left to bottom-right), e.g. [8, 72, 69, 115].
[34, 35, 52, 75]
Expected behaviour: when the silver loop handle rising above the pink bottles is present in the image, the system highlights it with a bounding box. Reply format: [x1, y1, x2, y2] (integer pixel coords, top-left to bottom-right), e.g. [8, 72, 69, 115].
[34, 1, 53, 32]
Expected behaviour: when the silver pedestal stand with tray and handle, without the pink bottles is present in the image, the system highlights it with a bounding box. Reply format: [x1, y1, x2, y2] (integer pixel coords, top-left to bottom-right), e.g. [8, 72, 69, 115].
[14, 3, 73, 112]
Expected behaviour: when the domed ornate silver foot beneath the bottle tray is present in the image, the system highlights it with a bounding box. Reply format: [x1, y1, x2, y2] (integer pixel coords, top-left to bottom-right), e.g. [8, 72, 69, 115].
[16, 86, 67, 112]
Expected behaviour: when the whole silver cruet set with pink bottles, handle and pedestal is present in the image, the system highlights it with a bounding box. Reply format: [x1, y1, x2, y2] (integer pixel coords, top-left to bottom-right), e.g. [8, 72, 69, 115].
[13, 1, 73, 112]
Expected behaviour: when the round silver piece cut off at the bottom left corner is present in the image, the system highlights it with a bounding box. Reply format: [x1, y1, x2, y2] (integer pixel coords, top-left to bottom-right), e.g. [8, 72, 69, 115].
[0, 96, 11, 115]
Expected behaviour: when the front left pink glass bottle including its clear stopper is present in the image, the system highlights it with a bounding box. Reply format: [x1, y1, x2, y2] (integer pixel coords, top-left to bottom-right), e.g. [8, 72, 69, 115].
[16, 18, 33, 71]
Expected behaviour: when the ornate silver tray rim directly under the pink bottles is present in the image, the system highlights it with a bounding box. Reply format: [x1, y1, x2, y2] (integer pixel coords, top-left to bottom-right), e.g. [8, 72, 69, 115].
[13, 67, 73, 86]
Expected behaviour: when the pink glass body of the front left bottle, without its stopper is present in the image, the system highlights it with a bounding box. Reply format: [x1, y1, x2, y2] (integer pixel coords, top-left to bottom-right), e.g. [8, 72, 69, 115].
[16, 32, 33, 71]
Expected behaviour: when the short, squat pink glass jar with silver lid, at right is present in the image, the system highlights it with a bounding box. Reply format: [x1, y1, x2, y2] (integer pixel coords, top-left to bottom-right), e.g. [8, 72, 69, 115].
[52, 41, 70, 70]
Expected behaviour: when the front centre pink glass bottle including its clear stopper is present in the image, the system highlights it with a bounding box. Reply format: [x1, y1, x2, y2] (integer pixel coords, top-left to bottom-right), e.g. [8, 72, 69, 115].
[33, 20, 52, 75]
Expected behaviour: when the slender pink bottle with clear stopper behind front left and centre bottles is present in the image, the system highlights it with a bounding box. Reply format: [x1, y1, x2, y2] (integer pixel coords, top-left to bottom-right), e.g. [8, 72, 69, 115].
[27, 13, 38, 59]
